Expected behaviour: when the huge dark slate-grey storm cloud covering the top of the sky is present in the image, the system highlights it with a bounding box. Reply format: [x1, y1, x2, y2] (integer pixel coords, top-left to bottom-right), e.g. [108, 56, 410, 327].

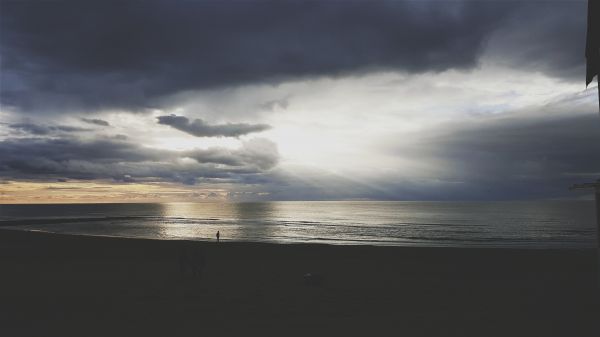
[0, 1, 519, 112]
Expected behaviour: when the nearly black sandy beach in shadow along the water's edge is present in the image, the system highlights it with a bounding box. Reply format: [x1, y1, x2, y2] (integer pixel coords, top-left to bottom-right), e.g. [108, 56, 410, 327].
[0, 230, 600, 337]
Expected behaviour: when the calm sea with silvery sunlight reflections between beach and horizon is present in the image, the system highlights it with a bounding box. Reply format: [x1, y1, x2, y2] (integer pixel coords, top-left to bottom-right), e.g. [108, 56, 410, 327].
[0, 201, 596, 248]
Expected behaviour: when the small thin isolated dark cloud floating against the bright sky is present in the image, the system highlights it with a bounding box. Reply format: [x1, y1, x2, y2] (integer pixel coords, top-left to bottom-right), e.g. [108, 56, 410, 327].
[157, 115, 271, 137]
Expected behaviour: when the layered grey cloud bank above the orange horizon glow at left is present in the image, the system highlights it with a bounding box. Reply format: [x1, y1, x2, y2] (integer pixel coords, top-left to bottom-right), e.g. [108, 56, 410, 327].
[0, 138, 278, 184]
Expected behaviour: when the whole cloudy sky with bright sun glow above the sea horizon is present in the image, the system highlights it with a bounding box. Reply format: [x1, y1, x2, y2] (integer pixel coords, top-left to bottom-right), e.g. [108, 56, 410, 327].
[0, 0, 600, 203]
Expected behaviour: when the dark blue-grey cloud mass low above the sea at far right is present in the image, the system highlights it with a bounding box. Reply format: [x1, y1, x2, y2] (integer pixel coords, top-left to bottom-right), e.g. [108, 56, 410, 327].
[426, 115, 600, 180]
